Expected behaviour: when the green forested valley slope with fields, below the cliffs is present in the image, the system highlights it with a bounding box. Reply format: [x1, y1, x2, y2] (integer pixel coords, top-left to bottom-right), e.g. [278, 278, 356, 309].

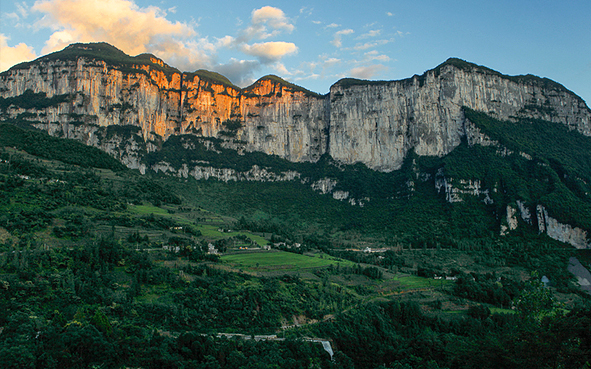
[0, 113, 591, 369]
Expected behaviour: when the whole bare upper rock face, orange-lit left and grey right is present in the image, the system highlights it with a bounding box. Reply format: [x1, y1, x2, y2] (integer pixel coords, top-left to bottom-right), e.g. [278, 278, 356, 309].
[0, 44, 591, 171]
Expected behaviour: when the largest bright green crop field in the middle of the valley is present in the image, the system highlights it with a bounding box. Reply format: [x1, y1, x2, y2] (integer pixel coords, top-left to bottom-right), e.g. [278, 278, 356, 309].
[221, 251, 355, 272]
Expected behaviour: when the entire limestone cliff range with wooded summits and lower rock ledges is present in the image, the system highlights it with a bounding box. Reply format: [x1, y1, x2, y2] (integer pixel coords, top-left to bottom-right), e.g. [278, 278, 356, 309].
[0, 44, 591, 247]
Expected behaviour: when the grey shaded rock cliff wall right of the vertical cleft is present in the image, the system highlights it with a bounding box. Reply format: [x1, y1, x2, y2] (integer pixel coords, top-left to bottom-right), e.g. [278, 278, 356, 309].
[329, 64, 591, 171]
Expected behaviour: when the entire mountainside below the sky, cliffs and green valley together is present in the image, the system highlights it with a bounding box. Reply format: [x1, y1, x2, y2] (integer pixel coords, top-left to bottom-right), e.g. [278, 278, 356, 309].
[0, 43, 591, 368]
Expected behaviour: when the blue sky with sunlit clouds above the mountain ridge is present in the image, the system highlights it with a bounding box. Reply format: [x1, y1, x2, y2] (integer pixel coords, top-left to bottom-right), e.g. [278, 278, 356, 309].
[0, 0, 591, 104]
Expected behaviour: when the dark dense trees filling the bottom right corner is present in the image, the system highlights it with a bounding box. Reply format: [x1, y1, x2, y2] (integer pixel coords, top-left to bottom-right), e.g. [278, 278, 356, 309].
[310, 302, 591, 368]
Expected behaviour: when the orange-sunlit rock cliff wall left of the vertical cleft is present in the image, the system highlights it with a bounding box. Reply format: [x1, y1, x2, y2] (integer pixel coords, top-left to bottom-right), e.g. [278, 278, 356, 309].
[0, 58, 329, 162]
